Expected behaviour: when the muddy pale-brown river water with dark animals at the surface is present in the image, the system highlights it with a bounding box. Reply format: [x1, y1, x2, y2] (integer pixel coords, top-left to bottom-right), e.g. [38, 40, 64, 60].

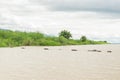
[0, 45, 120, 80]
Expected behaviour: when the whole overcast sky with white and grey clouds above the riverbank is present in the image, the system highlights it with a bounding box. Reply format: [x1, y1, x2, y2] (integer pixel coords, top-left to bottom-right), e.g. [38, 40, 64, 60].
[0, 0, 120, 43]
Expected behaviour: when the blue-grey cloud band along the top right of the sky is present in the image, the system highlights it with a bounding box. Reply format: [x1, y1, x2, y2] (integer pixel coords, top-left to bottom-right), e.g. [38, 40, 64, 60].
[31, 0, 120, 13]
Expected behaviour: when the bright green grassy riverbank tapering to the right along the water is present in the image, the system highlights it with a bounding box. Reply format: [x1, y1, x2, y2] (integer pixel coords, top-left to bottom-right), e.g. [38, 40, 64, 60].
[0, 30, 107, 47]
